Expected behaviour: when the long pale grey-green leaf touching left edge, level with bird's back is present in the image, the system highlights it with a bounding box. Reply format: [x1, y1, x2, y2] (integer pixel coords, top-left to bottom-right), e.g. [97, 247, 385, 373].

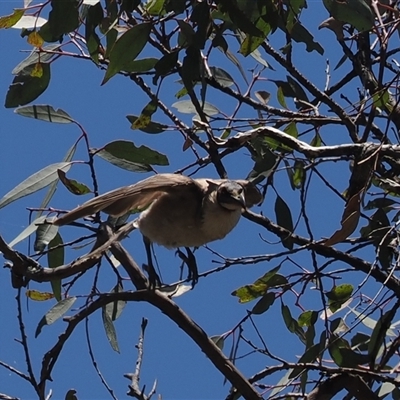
[0, 162, 71, 208]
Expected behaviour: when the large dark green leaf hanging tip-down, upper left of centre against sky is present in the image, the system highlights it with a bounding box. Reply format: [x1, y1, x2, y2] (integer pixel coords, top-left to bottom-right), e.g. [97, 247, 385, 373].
[101, 23, 152, 85]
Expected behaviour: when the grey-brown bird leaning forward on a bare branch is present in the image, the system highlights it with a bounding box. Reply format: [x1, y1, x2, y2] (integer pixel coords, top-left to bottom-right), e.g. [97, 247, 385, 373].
[53, 173, 262, 284]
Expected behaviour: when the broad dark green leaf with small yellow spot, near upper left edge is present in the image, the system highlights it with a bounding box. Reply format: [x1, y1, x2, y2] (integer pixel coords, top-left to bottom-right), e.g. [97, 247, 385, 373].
[4, 63, 50, 108]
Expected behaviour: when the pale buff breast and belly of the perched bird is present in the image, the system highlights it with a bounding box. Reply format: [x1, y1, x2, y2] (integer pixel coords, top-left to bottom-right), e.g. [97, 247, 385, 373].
[138, 194, 241, 248]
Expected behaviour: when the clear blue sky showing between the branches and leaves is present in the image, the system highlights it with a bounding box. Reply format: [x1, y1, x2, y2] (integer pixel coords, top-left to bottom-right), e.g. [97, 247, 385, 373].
[0, 0, 374, 399]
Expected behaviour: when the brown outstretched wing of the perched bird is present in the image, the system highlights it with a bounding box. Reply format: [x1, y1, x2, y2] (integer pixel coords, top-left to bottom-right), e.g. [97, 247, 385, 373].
[53, 174, 198, 226]
